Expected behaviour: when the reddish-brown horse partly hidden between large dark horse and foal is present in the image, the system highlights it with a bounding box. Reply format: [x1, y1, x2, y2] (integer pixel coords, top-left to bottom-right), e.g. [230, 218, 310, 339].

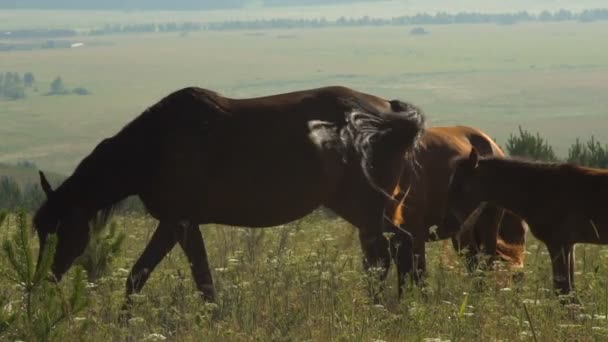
[396, 126, 526, 280]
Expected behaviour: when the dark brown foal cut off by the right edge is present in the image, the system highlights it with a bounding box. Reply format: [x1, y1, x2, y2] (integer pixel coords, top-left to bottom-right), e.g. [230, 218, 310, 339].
[448, 149, 608, 294]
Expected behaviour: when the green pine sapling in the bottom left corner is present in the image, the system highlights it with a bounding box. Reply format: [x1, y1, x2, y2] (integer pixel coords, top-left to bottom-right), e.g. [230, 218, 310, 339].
[0, 212, 86, 341]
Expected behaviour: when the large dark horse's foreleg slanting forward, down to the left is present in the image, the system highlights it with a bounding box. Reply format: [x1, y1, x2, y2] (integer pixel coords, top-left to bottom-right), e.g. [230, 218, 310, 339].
[123, 222, 177, 309]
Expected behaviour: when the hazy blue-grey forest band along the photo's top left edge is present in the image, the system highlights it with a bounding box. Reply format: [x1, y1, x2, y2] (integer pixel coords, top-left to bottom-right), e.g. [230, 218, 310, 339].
[0, 0, 374, 10]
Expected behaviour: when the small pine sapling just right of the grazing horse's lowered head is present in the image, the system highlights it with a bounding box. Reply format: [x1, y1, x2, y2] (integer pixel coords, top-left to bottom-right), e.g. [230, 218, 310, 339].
[75, 222, 126, 282]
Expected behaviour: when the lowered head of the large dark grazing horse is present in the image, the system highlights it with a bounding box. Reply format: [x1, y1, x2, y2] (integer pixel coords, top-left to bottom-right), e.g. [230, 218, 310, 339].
[34, 172, 90, 280]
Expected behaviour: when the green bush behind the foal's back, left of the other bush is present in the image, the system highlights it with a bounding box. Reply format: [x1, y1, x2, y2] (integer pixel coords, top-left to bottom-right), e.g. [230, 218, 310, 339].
[506, 126, 557, 161]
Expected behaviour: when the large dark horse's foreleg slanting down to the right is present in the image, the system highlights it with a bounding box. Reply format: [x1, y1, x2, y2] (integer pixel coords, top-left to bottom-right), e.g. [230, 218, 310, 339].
[173, 224, 215, 302]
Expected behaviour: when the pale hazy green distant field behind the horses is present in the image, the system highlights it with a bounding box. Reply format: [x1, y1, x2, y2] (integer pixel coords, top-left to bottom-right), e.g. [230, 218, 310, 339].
[0, 20, 608, 172]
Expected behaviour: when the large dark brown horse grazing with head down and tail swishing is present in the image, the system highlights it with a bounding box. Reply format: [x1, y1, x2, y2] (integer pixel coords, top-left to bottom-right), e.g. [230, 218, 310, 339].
[34, 87, 424, 301]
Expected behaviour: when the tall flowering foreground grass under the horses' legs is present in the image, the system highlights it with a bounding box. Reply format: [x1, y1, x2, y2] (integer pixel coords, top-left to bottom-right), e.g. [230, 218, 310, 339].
[0, 215, 608, 341]
